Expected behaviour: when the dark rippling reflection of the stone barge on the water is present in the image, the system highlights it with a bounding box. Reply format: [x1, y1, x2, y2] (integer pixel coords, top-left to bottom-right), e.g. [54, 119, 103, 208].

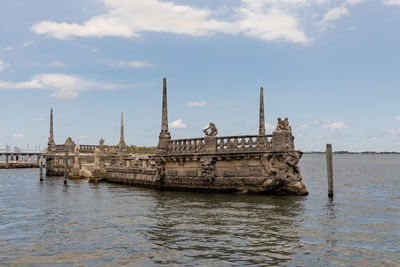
[147, 192, 304, 264]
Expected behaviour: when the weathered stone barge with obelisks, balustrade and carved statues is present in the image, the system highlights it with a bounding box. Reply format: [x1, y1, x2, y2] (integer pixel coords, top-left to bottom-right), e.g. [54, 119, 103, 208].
[45, 78, 308, 195]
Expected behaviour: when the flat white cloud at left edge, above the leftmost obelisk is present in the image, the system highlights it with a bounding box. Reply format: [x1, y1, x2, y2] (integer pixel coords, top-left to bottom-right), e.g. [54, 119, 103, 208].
[0, 74, 130, 99]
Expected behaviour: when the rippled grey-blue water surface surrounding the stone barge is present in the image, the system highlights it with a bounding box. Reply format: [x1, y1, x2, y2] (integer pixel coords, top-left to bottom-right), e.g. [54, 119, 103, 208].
[0, 155, 400, 266]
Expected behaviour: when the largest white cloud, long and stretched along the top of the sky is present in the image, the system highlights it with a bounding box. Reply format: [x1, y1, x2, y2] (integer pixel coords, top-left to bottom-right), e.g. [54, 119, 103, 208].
[32, 0, 308, 43]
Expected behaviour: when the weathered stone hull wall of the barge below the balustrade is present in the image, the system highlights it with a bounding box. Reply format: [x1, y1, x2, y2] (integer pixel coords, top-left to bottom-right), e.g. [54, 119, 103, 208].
[104, 151, 307, 195]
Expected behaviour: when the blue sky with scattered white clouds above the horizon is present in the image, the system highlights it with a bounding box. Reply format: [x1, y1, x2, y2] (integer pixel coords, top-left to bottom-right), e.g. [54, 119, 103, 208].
[0, 0, 400, 151]
